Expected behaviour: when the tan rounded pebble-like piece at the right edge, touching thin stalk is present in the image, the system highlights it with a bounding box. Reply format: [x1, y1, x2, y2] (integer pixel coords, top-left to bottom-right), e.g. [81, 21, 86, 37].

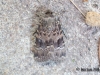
[86, 11, 100, 26]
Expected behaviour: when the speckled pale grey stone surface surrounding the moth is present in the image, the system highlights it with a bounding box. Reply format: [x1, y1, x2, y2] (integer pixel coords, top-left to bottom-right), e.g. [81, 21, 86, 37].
[0, 0, 100, 75]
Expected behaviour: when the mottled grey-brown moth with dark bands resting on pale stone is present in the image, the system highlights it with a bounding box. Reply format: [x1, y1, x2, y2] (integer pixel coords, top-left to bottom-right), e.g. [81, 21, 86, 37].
[32, 8, 66, 62]
